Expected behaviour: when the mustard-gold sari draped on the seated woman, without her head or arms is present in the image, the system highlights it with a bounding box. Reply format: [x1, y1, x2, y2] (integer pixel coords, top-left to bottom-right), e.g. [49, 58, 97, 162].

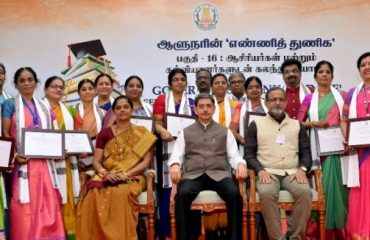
[77, 126, 156, 240]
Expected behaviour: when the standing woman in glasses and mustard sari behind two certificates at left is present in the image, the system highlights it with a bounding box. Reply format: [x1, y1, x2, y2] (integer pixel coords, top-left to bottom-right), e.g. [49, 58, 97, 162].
[43, 76, 80, 239]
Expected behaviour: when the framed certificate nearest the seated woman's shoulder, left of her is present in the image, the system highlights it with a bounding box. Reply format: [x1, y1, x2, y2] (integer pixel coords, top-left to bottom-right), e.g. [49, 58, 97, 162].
[64, 131, 94, 155]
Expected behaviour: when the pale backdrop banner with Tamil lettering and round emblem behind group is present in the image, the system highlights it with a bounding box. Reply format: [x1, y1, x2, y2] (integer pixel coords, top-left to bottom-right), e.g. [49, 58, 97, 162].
[0, 0, 370, 103]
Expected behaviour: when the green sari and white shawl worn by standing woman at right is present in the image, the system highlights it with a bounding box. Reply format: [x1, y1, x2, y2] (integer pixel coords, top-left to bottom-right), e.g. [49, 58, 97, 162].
[298, 90, 348, 239]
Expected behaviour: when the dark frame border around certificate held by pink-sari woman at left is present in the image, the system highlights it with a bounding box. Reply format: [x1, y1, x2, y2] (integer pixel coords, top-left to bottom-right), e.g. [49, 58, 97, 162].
[21, 128, 65, 159]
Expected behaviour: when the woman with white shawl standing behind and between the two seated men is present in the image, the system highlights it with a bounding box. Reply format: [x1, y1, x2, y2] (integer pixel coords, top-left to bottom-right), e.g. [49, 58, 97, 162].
[229, 76, 267, 148]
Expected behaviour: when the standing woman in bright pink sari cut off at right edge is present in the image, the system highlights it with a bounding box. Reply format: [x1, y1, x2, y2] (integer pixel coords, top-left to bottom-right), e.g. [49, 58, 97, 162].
[341, 52, 370, 239]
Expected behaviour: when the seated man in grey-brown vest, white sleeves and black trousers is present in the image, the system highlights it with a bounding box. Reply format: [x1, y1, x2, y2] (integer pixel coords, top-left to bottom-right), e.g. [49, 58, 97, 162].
[168, 93, 247, 240]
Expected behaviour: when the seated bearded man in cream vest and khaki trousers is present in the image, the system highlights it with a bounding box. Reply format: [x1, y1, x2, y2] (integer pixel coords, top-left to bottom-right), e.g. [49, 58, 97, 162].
[244, 87, 312, 239]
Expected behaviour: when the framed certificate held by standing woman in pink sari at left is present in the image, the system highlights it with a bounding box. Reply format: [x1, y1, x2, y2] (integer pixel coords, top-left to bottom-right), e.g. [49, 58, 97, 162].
[21, 128, 65, 159]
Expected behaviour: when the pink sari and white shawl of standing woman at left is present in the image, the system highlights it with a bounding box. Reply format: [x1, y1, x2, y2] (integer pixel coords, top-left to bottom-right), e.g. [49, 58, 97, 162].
[3, 96, 65, 239]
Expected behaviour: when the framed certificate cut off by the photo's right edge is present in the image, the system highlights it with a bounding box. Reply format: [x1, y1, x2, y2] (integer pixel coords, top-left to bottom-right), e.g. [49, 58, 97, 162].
[347, 117, 370, 148]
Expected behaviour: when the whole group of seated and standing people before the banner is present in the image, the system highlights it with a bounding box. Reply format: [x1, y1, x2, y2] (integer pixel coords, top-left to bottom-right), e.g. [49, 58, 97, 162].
[0, 52, 370, 239]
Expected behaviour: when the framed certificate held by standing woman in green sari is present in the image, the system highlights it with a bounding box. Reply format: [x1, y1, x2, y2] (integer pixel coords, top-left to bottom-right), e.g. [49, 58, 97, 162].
[315, 126, 344, 156]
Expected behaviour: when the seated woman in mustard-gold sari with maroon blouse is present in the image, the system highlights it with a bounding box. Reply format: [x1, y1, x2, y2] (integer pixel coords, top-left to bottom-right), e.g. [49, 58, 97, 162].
[77, 96, 156, 240]
